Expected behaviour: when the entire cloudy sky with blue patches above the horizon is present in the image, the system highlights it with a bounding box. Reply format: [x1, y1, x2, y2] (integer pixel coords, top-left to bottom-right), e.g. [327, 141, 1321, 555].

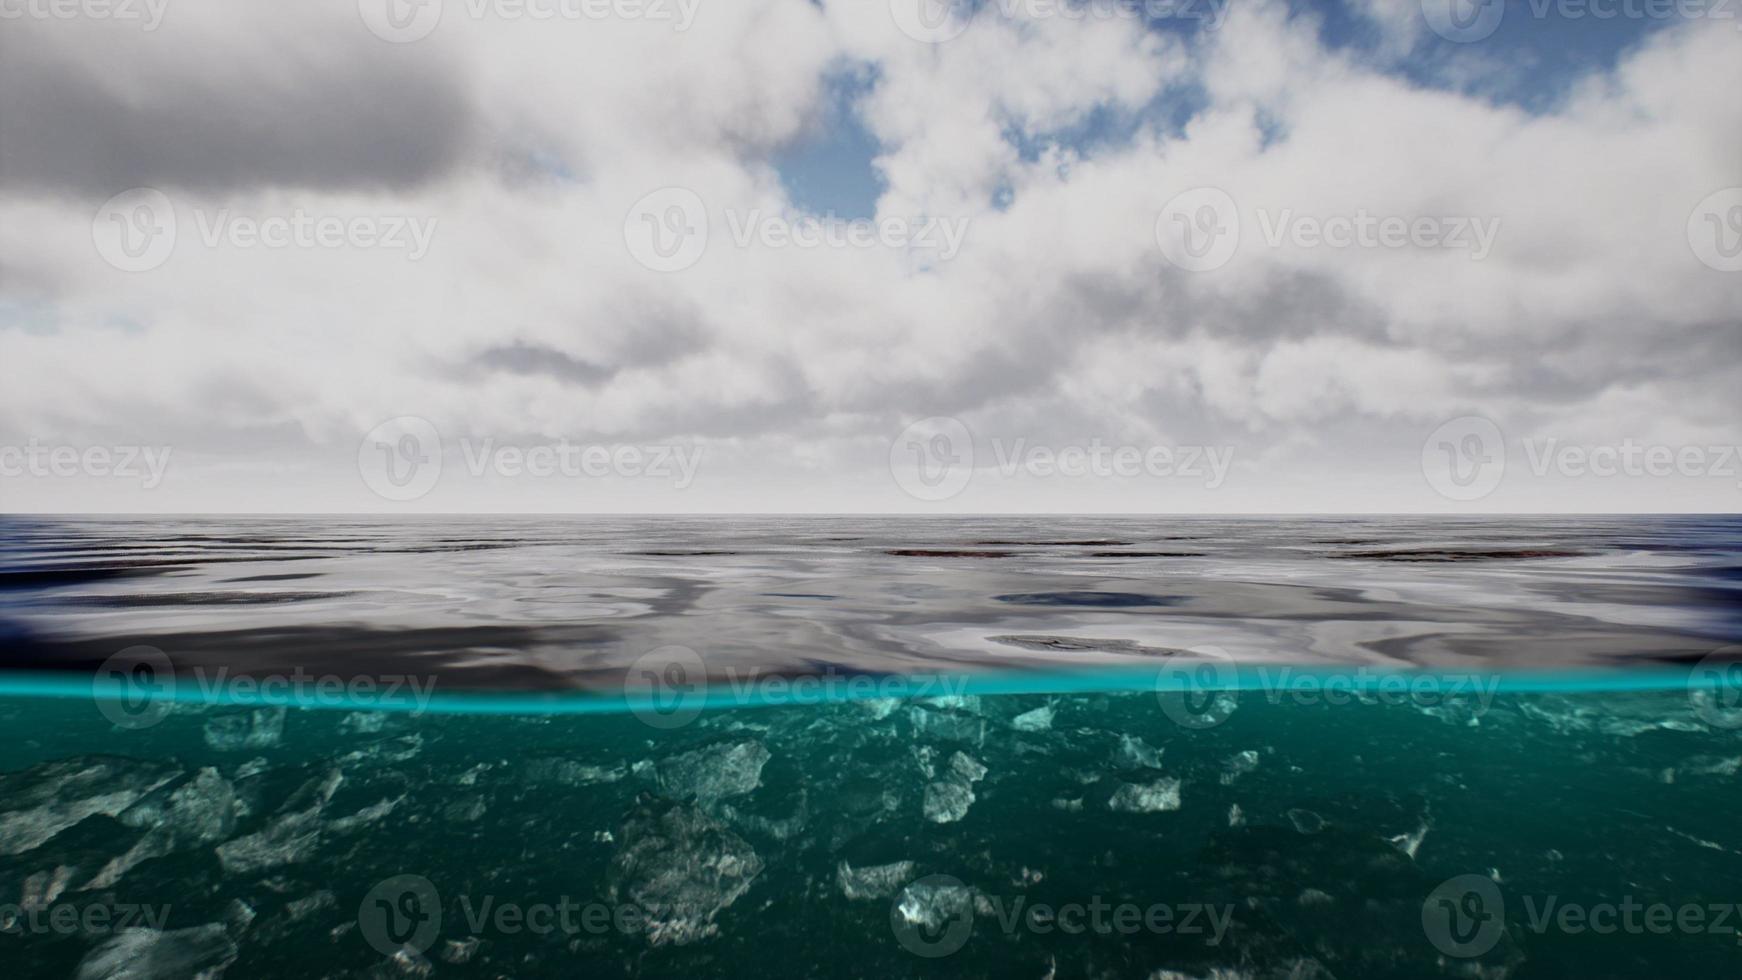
[0, 0, 1742, 513]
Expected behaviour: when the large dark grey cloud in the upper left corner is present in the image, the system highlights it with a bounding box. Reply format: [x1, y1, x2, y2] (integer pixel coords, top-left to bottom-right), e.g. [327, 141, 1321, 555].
[0, 17, 479, 198]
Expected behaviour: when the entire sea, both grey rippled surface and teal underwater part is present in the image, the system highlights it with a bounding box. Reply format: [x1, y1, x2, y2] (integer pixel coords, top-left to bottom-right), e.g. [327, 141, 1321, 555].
[0, 517, 1742, 980]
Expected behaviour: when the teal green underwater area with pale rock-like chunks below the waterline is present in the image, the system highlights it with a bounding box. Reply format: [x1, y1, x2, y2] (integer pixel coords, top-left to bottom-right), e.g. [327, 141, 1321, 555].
[0, 668, 1742, 978]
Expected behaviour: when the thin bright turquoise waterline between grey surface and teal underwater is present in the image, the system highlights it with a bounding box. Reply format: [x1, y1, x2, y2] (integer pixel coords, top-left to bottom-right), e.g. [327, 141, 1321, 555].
[0, 663, 1714, 715]
